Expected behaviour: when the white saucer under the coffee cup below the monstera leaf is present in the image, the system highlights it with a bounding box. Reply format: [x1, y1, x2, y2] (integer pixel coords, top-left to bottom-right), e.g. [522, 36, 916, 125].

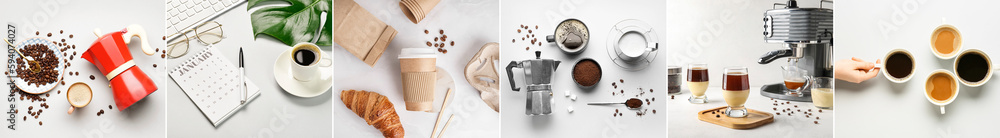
[274, 48, 333, 98]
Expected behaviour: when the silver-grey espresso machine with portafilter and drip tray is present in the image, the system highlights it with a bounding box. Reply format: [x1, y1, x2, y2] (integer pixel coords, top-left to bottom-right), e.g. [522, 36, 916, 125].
[757, 0, 833, 102]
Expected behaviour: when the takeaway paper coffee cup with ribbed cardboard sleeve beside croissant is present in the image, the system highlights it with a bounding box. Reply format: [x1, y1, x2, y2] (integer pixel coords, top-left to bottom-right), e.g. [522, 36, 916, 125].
[399, 48, 437, 112]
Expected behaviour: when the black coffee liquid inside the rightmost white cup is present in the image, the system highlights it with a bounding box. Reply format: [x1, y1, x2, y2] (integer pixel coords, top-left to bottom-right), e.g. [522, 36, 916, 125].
[955, 53, 990, 82]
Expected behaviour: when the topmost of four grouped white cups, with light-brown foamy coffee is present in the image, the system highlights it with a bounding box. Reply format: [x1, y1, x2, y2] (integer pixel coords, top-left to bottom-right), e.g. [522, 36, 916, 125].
[931, 24, 962, 59]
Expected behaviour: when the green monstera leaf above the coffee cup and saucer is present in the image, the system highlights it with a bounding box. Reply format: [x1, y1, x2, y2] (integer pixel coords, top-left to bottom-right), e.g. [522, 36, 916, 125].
[247, 0, 333, 46]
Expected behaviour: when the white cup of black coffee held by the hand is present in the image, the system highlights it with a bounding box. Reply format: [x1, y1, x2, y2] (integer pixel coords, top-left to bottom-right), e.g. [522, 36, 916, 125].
[882, 49, 917, 83]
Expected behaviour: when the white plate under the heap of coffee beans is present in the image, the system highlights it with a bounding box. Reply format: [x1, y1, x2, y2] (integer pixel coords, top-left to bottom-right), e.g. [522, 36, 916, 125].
[8, 37, 66, 94]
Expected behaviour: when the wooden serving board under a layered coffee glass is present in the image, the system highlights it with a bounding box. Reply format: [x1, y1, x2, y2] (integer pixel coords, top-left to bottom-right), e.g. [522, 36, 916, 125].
[698, 106, 774, 129]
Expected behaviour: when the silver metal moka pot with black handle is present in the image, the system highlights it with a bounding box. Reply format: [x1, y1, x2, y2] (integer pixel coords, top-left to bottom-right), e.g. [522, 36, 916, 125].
[507, 51, 561, 115]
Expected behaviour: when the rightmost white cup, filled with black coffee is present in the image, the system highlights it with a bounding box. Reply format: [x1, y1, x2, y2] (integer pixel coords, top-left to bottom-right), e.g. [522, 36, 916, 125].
[954, 49, 993, 87]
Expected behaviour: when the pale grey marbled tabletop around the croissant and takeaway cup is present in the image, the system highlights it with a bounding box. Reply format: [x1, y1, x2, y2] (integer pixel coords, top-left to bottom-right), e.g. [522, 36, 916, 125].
[333, 0, 507, 137]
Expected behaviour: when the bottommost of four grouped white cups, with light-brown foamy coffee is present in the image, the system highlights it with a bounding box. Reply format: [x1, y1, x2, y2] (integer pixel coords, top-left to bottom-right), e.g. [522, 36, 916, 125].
[924, 69, 959, 114]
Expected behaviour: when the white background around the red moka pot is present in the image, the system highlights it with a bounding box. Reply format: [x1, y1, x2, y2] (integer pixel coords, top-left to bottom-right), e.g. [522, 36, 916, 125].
[0, 0, 167, 137]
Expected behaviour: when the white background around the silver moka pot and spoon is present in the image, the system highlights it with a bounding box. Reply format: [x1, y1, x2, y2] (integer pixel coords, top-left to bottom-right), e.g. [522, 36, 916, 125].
[500, 0, 672, 138]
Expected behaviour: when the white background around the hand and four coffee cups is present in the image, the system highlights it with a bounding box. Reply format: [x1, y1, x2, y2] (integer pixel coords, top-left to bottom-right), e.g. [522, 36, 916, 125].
[834, 0, 1000, 137]
